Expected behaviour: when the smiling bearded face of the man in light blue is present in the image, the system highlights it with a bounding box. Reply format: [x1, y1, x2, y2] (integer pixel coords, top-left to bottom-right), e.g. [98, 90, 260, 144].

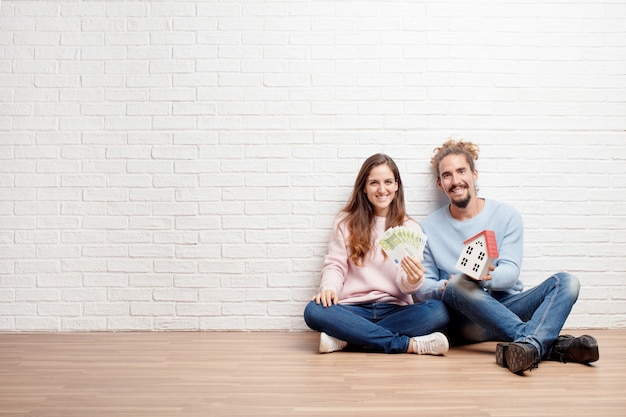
[437, 154, 478, 208]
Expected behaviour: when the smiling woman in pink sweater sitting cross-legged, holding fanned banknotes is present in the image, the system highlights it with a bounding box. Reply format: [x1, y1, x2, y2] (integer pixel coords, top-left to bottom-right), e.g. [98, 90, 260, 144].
[304, 154, 449, 355]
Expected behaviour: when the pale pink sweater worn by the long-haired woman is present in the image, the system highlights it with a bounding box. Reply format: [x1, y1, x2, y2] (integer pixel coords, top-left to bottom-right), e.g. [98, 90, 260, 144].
[320, 213, 424, 305]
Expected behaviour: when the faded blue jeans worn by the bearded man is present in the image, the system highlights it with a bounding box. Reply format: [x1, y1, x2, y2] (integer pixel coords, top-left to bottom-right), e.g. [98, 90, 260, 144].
[443, 272, 580, 358]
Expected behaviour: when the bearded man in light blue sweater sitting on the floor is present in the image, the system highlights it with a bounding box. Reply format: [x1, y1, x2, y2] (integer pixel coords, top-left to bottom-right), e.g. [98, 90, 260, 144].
[408, 140, 599, 373]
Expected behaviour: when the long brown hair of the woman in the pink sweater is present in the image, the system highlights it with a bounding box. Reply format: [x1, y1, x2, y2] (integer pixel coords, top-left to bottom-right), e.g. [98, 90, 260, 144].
[342, 153, 407, 266]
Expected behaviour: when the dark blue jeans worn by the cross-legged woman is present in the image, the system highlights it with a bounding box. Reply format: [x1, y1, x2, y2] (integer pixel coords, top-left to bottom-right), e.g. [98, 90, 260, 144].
[304, 300, 449, 353]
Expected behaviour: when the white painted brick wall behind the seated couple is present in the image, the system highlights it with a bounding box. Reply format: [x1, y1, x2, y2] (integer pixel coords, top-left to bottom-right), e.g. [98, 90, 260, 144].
[0, 0, 626, 331]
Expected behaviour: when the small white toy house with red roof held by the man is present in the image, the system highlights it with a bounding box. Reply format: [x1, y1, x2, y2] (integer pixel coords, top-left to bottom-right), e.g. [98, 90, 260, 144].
[456, 230, 498, 279]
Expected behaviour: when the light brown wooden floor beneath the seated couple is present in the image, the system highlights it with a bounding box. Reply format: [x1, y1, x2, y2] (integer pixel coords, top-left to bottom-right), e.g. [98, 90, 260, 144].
[0, 329, 626, 417]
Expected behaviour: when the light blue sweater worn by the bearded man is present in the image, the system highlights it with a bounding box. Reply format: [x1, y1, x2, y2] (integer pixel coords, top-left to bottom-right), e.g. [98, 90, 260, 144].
[415, 199, 524, 300]
